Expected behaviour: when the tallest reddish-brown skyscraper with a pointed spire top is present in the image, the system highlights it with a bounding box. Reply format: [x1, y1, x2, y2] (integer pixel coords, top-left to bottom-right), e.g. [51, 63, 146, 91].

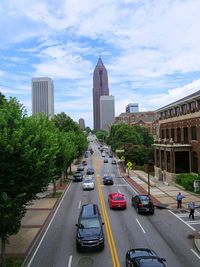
[93, 57, 109, 131]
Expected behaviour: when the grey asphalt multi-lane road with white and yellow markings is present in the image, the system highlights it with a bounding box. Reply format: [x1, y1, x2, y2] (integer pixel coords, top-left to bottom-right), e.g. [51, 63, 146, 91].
[27, 142, 200, 267]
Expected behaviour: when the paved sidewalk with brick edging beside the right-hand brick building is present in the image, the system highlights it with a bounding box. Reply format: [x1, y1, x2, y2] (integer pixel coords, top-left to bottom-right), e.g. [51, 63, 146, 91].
[121, 170, 200, 252]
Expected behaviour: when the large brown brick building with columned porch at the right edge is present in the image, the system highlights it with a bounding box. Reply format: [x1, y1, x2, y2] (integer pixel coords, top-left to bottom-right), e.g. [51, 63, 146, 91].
[154, 91, 200, 182]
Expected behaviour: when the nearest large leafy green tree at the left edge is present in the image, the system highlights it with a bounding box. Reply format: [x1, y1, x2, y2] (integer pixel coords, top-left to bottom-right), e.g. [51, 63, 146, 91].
[0, 98, 59, 261]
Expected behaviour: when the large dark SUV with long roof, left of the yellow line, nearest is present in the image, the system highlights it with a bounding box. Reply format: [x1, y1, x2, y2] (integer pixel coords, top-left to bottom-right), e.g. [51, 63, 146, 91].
[76, 204, 104, 251]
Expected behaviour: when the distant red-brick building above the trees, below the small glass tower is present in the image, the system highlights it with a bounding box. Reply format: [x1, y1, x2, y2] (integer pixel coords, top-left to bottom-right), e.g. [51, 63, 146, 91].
[115, 111, 158, 137]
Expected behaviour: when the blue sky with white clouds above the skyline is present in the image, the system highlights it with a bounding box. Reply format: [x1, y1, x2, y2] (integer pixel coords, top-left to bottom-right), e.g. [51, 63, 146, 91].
[0, 0, 200, 129]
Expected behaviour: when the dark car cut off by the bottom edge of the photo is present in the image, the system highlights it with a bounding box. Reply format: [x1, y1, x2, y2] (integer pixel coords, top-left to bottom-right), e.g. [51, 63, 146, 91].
[126, 248, 166, 267]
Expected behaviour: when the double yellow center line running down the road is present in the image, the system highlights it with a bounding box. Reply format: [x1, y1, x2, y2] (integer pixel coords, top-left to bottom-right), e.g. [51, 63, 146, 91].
[94, 157, 120, 267]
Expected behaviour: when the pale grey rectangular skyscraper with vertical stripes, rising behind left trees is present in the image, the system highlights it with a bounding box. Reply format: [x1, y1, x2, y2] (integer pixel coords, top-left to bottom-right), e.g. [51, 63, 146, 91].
[31, 77, 54, 119]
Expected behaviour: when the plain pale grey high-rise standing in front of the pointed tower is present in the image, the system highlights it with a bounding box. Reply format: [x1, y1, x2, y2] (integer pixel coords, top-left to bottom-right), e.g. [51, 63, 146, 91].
[100, 96, 115, 131]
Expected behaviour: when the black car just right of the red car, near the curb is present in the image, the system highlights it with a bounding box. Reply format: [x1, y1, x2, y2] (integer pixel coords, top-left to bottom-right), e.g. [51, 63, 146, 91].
[131, 195, 155, 214]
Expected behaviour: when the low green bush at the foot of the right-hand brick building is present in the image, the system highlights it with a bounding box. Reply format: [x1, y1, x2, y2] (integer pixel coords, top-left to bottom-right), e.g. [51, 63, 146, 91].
[176, 173, 200, 191]
